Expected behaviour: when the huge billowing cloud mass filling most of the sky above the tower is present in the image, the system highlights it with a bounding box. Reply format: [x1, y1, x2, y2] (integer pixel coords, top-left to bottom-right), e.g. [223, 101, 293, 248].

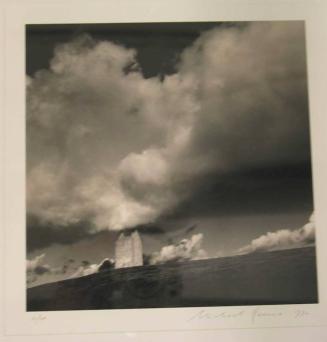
[27, 22, 310, 244]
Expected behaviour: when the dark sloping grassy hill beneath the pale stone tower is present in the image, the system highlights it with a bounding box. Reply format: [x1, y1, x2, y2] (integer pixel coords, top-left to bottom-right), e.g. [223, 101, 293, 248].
[27, 247, 318, 311]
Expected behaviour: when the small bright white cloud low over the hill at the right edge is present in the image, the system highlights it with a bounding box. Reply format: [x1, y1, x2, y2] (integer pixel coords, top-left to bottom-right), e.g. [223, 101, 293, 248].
[237, 214, 315, 254]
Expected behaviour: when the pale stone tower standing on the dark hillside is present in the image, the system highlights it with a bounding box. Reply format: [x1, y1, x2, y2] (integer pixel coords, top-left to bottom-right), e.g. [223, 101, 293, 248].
[115, 231, 143, 268]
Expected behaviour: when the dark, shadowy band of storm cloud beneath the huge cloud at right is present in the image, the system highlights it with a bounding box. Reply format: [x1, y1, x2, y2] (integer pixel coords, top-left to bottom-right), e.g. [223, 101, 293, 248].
[168, 163, 313, 219]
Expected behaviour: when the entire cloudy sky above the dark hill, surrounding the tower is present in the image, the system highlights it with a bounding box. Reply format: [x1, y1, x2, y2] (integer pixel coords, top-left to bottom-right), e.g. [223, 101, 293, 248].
[26, 21, 314, 285]
